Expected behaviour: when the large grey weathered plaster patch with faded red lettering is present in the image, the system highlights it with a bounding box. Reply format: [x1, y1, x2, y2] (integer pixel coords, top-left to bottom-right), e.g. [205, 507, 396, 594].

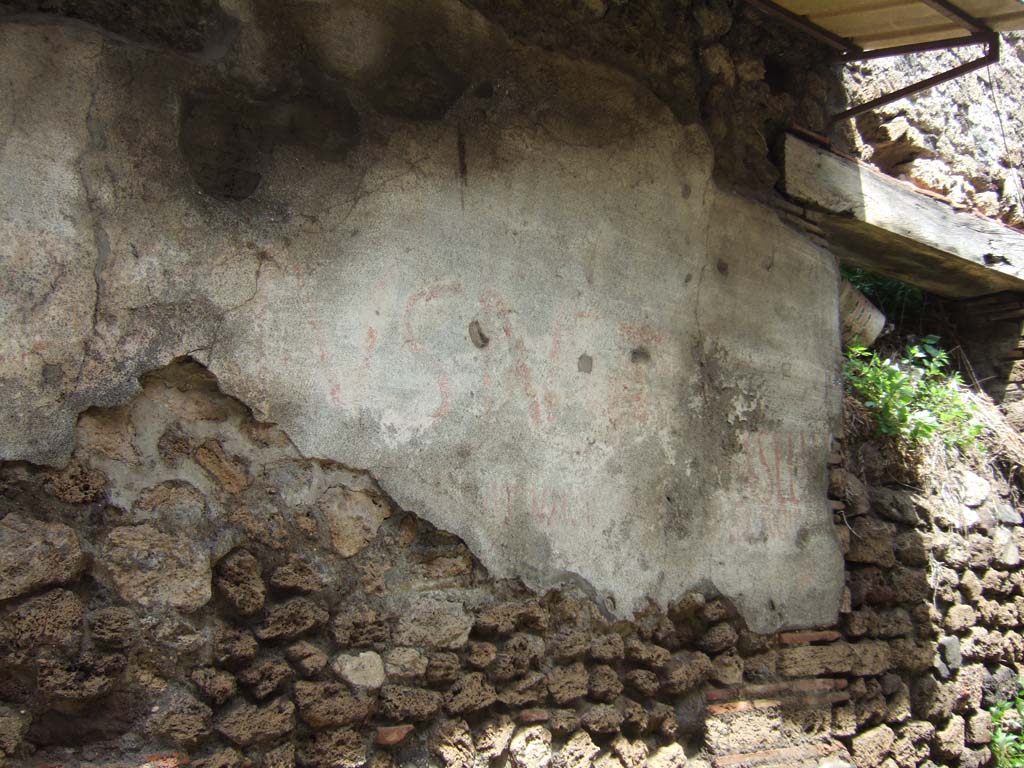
[0, 4, 843, 630]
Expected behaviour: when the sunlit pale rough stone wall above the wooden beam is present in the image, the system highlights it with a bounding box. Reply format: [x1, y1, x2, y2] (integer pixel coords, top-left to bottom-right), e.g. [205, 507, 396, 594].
[845, 33, 1024, 227]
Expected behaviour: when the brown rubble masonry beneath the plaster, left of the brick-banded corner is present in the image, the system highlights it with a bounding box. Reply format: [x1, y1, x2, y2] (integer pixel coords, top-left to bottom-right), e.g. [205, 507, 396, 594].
[0, 361, 770, 768]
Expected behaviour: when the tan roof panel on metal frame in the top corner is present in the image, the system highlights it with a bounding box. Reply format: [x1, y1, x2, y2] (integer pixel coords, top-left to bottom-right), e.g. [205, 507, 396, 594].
[775, 0, 1024, 50]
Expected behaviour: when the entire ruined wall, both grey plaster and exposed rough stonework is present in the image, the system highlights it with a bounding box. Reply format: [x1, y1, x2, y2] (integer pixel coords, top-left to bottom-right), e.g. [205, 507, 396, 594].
[8, 0, 1024, 768]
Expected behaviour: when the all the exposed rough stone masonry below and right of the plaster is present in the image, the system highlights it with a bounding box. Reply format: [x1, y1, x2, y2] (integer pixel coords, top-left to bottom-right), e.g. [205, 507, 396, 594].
[0, 360, 1024, 768]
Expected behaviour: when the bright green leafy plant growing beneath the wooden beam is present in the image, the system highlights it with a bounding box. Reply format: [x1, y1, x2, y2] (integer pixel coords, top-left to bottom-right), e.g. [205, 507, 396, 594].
[844, 336, 982, 450]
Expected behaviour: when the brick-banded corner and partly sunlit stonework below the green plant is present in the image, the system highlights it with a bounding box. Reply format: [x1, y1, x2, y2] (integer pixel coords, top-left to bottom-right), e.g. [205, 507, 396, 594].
[705, 401, 1024, 768]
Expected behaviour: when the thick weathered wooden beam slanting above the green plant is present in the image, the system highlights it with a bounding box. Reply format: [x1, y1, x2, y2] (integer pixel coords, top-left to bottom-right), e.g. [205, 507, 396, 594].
[784, 134, 1024, 298]
